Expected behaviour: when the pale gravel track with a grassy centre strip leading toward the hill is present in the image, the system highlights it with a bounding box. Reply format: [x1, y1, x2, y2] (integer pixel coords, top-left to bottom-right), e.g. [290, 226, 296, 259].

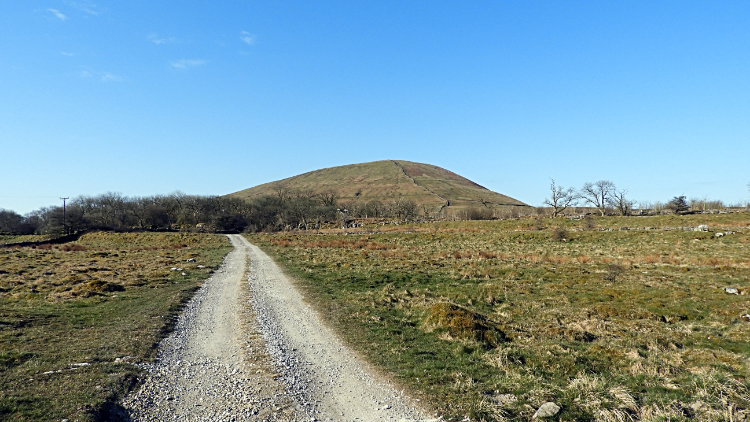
[123, 235, 432, 422]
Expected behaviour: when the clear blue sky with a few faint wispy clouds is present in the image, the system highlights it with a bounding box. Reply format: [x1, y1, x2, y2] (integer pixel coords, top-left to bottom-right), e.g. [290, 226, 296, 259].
[0, 0, 750, 214]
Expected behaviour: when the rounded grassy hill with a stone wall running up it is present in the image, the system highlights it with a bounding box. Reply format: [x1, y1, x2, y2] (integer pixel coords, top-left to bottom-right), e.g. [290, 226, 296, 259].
[227, 160, 528, 216]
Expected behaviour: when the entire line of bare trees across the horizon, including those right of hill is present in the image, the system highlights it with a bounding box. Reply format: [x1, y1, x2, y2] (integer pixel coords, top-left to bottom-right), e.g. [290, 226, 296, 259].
[0, 179, 750, 235]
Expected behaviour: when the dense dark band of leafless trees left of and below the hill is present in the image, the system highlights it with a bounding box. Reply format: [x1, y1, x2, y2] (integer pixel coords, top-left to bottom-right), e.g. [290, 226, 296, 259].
[0, 188, 418, 235]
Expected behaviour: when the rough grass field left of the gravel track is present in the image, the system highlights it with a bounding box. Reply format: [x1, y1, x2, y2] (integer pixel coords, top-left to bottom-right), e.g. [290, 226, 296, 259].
[0, 233, 231, 421]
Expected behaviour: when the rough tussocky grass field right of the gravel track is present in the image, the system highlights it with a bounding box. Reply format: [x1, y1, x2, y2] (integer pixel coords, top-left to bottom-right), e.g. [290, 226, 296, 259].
[248, 213, 750, 421]
